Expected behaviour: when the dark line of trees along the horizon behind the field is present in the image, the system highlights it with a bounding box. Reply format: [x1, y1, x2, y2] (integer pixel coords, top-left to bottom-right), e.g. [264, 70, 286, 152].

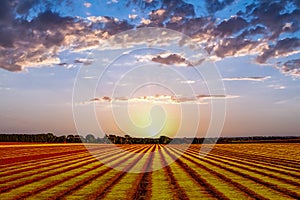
[0, 133, 300, 144]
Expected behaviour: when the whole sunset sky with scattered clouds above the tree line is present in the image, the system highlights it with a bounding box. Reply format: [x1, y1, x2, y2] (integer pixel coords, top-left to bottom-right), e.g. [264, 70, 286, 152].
[0, 0, 300, 137]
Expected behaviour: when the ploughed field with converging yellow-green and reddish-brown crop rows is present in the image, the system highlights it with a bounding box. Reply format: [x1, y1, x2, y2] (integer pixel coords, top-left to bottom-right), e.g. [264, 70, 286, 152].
[0, 143, 300, 200]
